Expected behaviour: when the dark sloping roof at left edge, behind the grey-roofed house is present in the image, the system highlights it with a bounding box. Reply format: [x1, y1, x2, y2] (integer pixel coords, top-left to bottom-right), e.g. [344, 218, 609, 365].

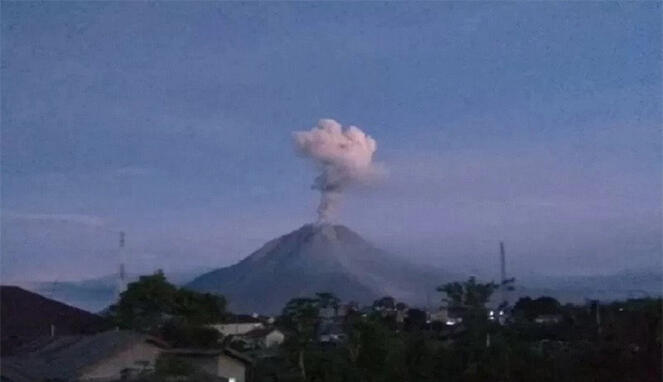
[0, 285, 111, 356]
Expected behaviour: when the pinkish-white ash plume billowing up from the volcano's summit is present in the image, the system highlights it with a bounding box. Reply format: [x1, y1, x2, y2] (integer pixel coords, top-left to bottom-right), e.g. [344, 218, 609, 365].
[293, 119, 380, 222]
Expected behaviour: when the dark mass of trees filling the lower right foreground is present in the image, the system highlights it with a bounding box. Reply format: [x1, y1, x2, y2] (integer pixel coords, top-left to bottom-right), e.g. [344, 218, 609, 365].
[255, 279, 663, 382]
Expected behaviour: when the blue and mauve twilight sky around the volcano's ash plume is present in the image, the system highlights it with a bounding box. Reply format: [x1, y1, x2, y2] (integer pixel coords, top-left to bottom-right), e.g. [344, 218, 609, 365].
[1, 1, 663, 282]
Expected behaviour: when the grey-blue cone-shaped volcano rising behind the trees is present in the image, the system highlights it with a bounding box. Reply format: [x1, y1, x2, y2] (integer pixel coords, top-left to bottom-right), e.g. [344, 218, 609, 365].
[187, 224, 452, 313]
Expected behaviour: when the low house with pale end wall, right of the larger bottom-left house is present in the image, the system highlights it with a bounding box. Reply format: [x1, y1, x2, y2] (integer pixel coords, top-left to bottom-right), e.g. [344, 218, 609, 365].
[165, 348, 253, 382]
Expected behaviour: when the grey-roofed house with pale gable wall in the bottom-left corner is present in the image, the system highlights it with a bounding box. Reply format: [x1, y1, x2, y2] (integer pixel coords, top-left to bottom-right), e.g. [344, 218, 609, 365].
[0, 330, 167, 382]
